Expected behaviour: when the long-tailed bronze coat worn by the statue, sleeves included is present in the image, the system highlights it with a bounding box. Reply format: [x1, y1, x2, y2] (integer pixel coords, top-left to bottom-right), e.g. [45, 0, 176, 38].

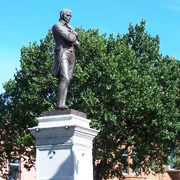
[52, 20, 76, 78]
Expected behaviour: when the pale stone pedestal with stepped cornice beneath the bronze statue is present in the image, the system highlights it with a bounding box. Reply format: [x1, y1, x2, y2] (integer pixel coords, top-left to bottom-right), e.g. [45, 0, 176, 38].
[29, 110, 98, 180]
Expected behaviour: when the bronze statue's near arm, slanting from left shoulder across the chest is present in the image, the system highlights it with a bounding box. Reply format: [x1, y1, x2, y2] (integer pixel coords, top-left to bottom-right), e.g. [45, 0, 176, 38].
[53, 25, 76, 44]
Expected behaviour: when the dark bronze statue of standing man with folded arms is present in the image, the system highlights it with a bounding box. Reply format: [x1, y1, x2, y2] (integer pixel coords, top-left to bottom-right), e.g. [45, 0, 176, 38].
[52, 9, 80, 110]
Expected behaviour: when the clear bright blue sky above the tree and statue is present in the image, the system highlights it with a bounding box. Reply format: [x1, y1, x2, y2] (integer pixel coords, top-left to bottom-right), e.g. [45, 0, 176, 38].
[0, 0, 180, 93]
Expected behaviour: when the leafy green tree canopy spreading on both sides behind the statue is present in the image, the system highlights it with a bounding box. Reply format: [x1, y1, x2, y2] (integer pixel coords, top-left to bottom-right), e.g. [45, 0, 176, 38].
[0, 21, 180, 180]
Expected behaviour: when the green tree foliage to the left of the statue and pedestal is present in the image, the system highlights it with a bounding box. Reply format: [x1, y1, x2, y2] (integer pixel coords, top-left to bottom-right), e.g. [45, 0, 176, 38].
[0, 31, 57, 178]
